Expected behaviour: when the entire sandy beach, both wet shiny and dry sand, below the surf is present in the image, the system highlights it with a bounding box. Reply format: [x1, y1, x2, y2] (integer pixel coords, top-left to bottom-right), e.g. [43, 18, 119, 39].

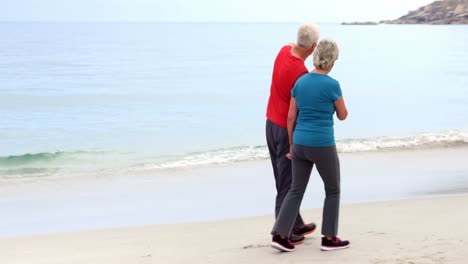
[0, 148, 468, 264]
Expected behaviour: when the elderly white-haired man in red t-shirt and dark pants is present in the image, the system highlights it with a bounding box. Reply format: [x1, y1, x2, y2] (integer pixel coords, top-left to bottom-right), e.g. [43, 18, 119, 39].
[266, 24, 319, 245]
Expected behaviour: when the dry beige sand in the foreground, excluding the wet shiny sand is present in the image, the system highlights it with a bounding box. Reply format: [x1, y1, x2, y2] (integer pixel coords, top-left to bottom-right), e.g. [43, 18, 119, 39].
[0, 195, 468, 264]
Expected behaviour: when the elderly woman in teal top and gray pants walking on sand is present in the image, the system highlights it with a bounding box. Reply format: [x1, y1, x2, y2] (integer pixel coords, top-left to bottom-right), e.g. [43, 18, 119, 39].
[271, 40, 349, 251]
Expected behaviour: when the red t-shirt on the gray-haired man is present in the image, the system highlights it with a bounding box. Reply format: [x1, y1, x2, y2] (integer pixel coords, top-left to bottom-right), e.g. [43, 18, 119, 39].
[266, 45, 308, 128]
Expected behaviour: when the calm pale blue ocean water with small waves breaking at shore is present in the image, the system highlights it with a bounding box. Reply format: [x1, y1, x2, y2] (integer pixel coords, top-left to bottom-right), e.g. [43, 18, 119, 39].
[0, 23, 468, 181]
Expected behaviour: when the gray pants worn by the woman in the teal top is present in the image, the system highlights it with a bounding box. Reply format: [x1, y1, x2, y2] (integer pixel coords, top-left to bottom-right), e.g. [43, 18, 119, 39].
[272, 144, 340, 236]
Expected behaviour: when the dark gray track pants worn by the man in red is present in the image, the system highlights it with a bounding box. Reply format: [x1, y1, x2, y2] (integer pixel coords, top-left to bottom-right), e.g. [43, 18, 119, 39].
[266, 119, 304, 227]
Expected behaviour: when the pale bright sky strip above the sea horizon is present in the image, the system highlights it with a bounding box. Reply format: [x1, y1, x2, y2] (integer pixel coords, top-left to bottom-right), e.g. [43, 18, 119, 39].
[0, 0, 433, 23]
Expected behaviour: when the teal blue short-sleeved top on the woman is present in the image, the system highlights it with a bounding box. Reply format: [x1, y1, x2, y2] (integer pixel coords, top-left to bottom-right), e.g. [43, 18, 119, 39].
[291, 72, 342, 147]
